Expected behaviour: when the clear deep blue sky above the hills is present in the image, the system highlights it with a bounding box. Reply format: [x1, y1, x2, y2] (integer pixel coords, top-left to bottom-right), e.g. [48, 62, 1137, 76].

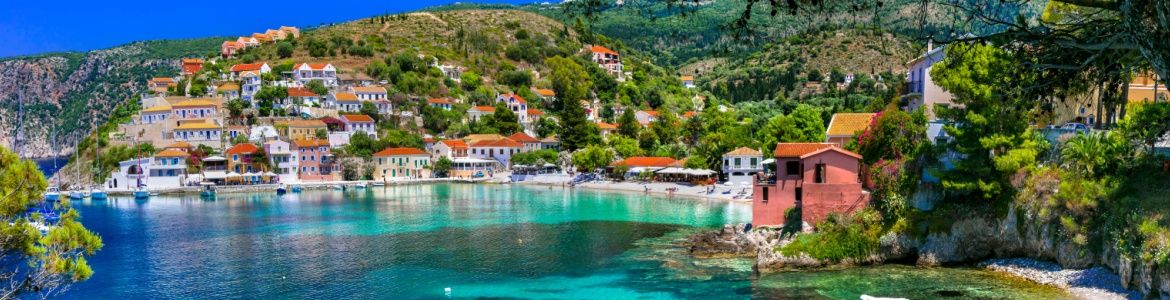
[0, 0, 534, 57]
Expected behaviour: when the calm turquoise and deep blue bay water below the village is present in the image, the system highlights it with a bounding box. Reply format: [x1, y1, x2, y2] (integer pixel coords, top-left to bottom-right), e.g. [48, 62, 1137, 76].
[64, 184, 1061, 299]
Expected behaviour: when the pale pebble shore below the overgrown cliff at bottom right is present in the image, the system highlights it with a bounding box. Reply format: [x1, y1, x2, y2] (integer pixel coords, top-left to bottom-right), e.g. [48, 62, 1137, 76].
[977, 258, 1142, 300]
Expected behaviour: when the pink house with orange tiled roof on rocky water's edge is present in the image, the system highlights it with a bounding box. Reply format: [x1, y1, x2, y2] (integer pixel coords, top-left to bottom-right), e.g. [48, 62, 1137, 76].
[751, 143, 869, 226]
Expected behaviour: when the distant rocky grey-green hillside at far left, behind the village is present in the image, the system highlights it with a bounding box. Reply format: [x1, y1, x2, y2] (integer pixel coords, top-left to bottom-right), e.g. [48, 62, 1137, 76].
[0, 38, 221, 157]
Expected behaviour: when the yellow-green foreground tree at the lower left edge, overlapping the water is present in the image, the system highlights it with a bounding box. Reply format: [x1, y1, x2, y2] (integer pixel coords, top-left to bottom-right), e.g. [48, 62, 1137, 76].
[0, 146, 103, 299]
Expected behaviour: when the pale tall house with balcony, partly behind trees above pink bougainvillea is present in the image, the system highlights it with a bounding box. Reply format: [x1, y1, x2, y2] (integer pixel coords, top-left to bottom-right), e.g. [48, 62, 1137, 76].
[902, 46, 955, 121]
